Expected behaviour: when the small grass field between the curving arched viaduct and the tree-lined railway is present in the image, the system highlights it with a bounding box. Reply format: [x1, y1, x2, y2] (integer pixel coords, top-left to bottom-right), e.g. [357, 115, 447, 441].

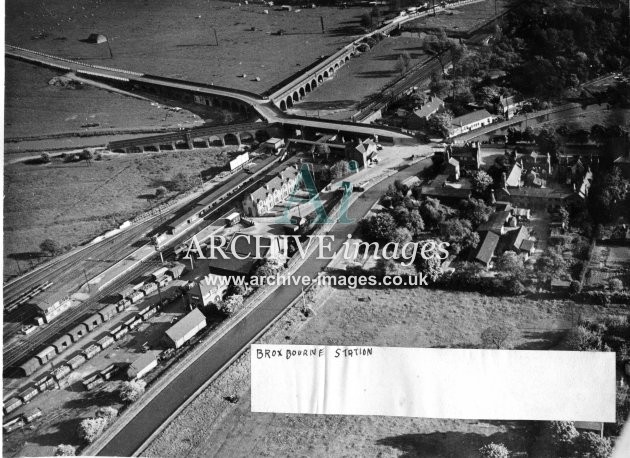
[293, 37, 427, 118]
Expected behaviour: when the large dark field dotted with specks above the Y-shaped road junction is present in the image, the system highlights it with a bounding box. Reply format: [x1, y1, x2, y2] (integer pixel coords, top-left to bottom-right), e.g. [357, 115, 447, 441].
[6, 0, 367, 92]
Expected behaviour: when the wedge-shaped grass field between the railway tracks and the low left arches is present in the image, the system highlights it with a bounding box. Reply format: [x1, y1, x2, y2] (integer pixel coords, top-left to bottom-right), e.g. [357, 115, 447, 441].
[3, 148, 237, 275]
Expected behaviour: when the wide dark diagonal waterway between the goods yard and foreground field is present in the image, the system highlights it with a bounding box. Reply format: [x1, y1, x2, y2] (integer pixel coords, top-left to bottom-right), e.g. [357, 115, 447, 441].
[98, 160, 431, 456]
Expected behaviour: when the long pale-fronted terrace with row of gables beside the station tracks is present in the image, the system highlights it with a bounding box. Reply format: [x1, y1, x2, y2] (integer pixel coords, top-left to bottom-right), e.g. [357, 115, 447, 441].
[242, 165, 302, 217]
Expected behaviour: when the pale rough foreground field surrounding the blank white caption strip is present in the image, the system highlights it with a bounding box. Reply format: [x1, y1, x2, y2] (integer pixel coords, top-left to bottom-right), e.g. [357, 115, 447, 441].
[143, 289, 590, 457]
